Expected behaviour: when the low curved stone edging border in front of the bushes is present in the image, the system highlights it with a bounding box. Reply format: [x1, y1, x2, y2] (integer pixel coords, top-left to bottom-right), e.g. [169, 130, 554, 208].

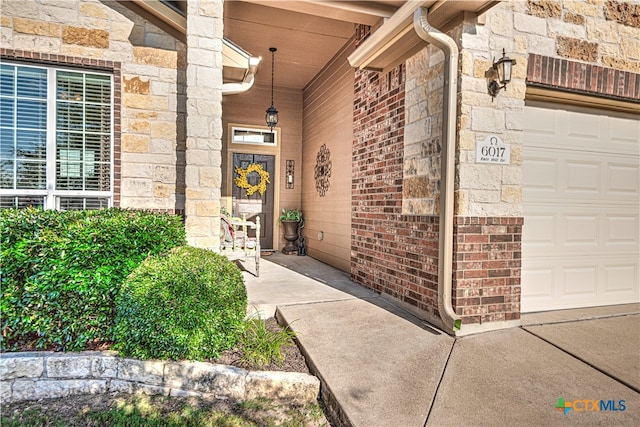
[0, 351, 320, 405]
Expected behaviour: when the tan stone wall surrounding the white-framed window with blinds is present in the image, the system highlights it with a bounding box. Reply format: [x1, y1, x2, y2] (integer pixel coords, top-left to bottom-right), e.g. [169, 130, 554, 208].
[0, 0, 185, 212]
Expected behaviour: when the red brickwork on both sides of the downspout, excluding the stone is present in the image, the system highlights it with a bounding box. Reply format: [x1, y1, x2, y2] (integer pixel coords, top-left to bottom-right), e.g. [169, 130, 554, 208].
[351, 61, 523, 324]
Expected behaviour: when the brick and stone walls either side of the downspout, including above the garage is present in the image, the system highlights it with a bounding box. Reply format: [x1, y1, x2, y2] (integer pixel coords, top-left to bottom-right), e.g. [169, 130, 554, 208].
[351, 0, 640, 332]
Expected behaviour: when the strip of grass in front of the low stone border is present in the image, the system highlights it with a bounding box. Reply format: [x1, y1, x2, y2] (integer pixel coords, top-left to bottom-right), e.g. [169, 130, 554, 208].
[0, 394, 329, 427]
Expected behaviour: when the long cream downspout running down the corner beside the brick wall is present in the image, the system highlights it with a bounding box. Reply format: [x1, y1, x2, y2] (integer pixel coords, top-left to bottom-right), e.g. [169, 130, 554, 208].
[413, 7, 462, 333]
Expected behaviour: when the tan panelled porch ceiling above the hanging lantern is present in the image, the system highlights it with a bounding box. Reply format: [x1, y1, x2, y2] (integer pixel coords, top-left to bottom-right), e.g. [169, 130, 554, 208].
[224, 0, 405, 89]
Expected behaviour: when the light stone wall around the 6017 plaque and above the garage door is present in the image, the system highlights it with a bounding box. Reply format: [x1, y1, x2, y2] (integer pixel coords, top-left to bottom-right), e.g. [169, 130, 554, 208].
[454, 0, 640, 217]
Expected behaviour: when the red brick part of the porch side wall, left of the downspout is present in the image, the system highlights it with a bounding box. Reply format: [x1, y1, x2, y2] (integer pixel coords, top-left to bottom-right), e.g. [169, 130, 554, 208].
[351, 66, 438, 314]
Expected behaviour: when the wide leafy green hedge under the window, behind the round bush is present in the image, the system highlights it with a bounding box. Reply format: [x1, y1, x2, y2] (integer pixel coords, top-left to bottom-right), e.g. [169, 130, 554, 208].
[0, 208, 185, 351]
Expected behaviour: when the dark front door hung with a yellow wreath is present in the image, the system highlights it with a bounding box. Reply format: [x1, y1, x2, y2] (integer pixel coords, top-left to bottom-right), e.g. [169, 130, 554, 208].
[232, 153, 275, 249]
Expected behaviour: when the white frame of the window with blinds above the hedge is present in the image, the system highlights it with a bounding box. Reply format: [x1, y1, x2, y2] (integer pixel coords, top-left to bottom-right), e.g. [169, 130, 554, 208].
[0, 60, 115, 209]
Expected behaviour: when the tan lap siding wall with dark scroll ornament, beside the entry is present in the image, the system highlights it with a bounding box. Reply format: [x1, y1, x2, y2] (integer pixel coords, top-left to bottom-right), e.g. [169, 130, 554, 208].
[302, 36, 354, 271]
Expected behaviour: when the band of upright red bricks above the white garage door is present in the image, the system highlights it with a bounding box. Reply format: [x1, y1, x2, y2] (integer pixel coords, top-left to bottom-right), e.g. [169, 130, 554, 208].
[527, 54, 640, 102]
